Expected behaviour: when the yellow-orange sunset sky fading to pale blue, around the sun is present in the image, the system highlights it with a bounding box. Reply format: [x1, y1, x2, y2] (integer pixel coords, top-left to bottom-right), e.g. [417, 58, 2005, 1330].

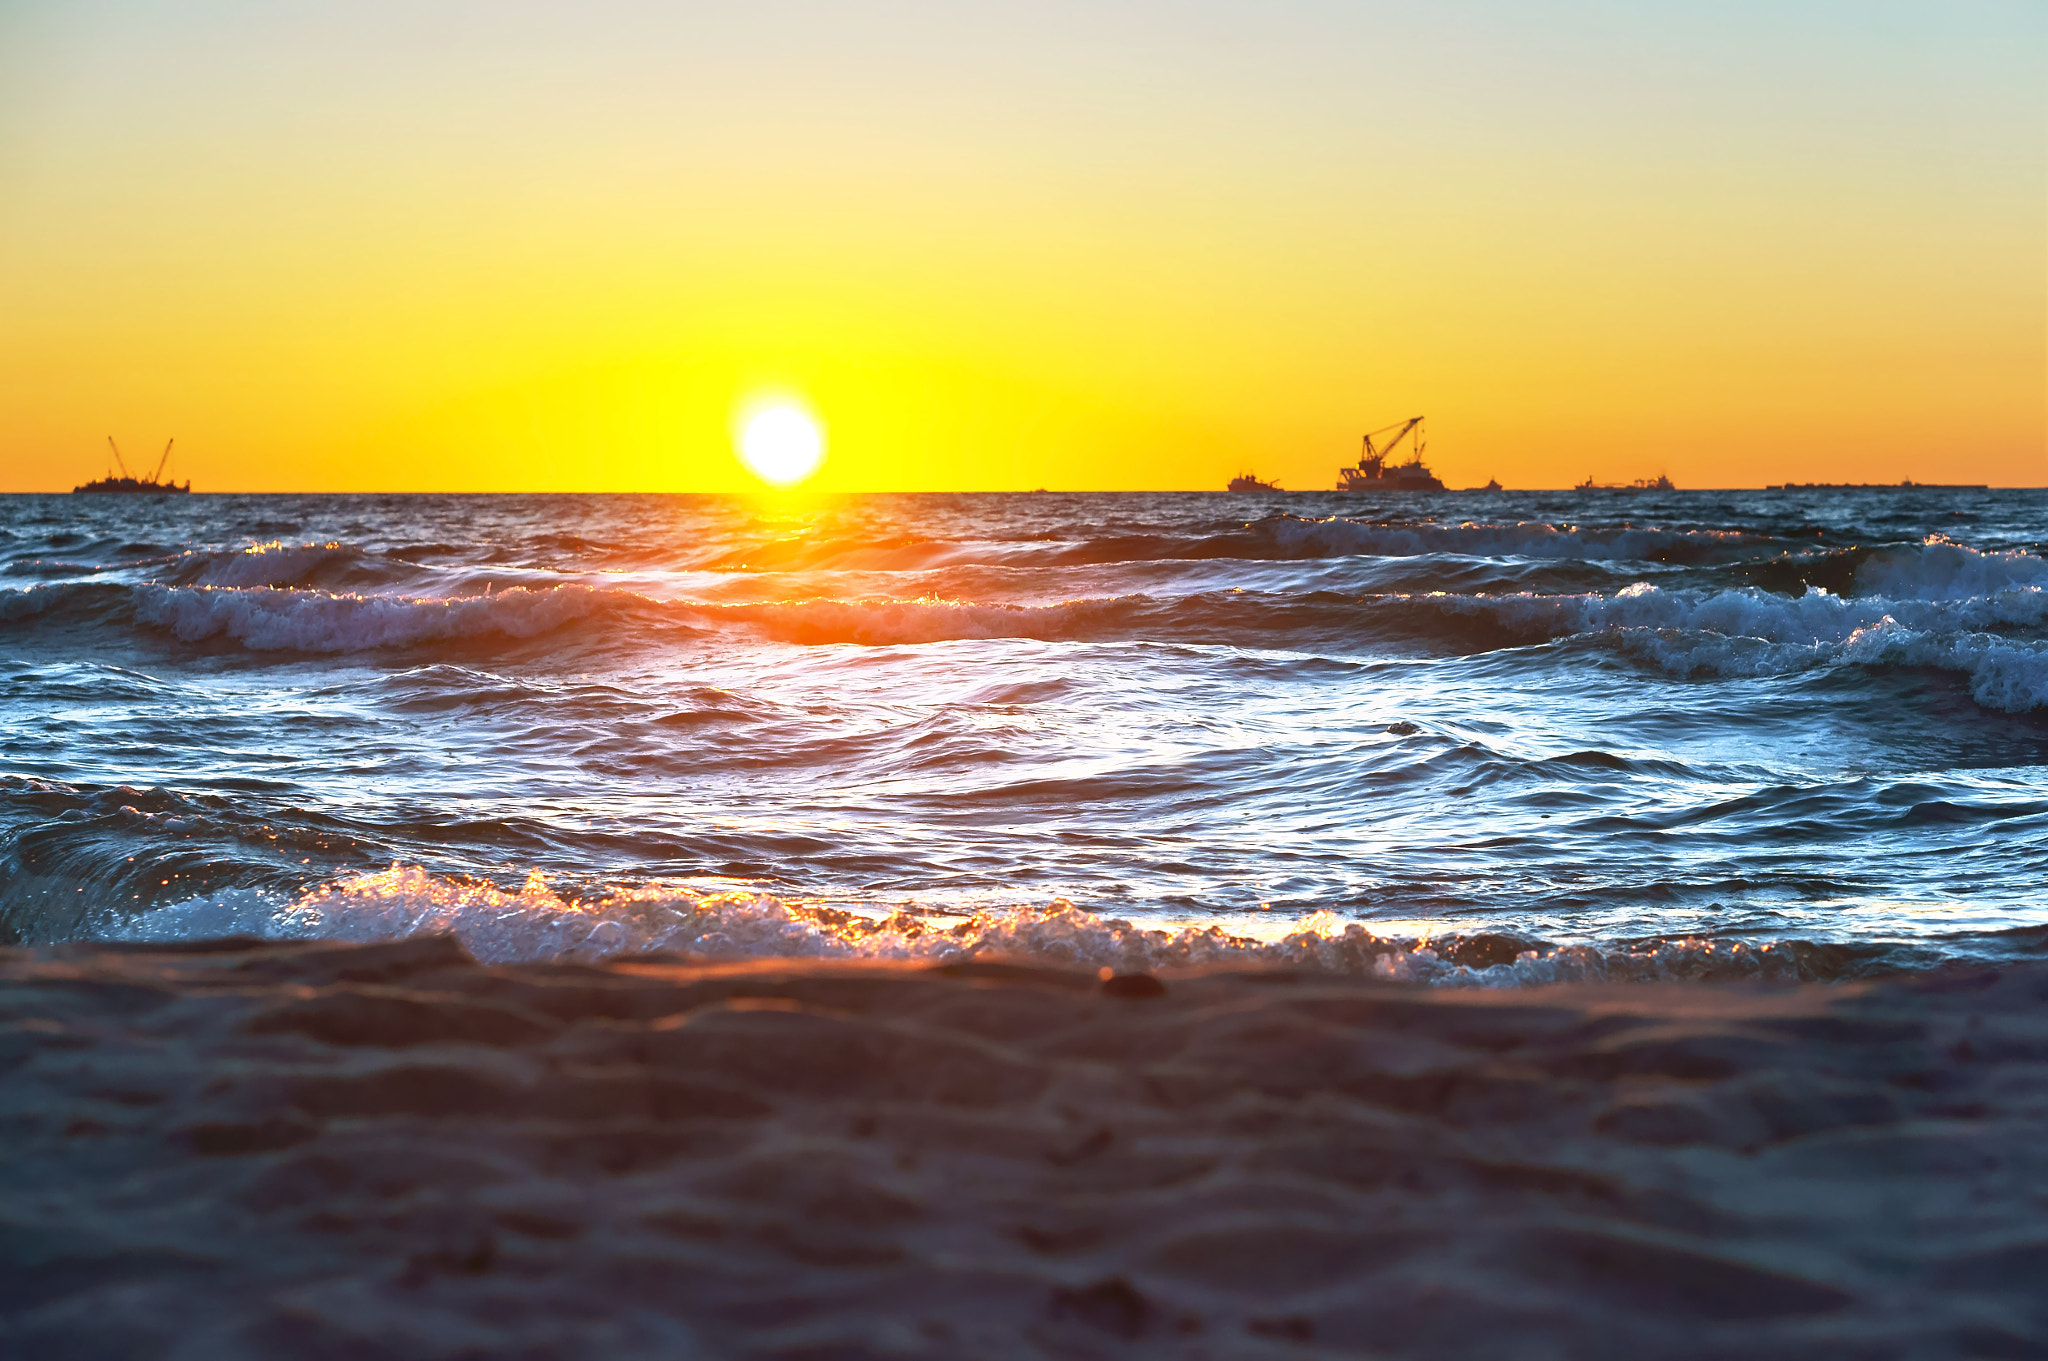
[0, 0, 2048, 491]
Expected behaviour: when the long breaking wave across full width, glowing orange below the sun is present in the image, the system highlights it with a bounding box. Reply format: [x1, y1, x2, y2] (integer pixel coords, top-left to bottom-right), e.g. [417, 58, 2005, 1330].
[16, 568, 2048, 712]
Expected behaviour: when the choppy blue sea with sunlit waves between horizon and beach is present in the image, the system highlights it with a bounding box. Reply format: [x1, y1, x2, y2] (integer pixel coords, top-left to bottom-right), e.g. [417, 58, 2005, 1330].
[0, 491, 2048, 984]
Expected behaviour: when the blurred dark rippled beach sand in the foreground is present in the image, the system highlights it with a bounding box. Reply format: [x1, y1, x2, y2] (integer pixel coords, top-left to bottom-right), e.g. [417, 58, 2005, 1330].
[0, 937, 2048, 1361]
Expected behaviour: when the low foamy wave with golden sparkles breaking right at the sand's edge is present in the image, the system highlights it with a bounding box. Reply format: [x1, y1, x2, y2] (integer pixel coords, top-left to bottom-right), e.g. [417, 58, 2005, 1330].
[88, 864, 1880, 986]
